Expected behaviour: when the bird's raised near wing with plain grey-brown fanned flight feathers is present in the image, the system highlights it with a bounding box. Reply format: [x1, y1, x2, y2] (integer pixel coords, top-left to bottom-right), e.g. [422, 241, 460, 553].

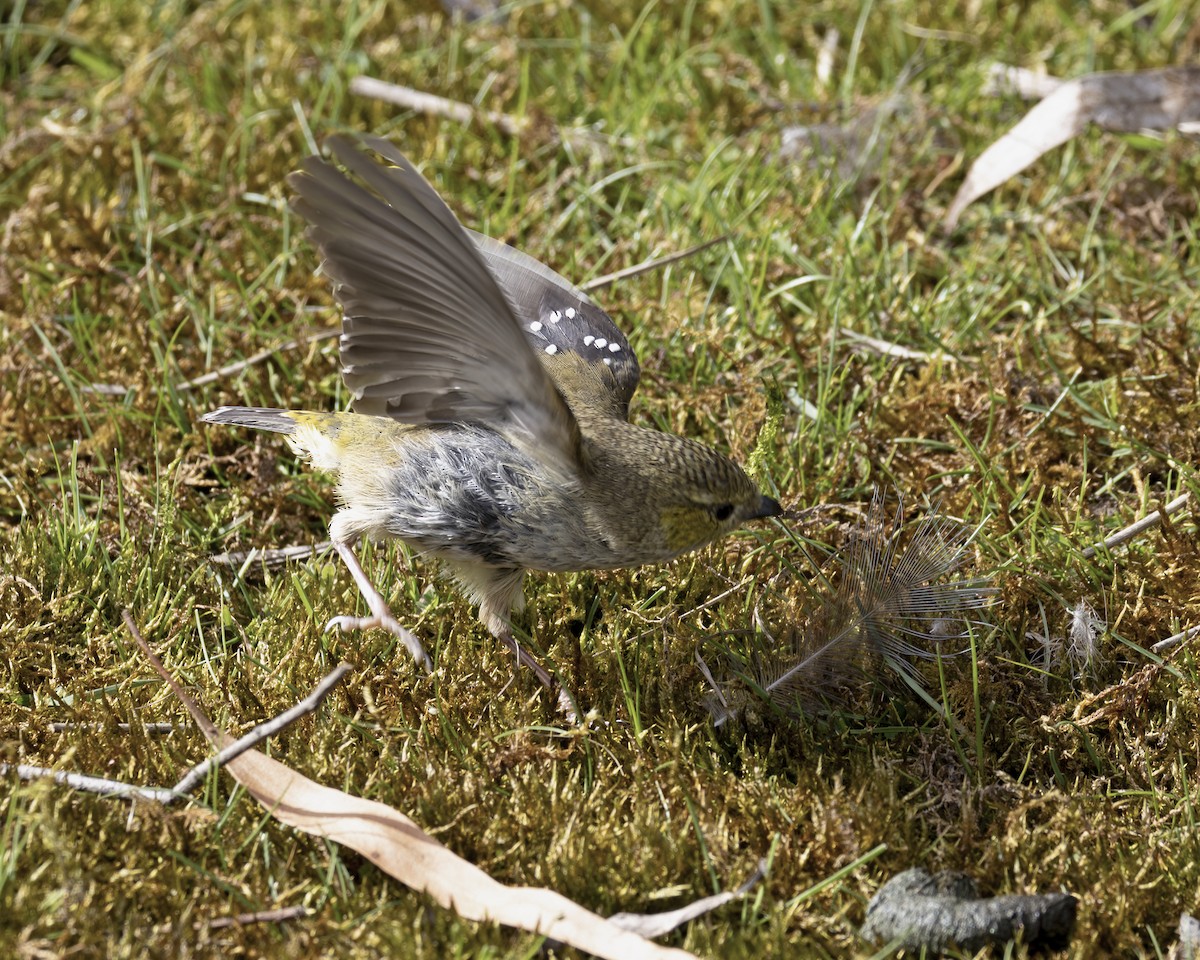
[288, 137, 578, 468]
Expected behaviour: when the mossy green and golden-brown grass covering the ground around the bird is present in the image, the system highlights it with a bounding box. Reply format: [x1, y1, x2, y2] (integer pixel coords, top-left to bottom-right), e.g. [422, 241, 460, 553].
[0, 0, 1200, 958]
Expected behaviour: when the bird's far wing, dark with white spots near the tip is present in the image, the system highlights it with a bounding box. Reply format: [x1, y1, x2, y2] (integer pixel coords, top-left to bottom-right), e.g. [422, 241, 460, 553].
[468, 230, 641, 408]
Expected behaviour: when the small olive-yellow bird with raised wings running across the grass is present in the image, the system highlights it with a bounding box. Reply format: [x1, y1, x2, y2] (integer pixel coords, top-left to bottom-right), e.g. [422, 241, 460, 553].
[202, 137, 780, 702]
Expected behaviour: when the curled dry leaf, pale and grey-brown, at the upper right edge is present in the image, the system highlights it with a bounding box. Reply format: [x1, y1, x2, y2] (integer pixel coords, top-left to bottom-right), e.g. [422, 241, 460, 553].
[944, 67, 1200, 230]
